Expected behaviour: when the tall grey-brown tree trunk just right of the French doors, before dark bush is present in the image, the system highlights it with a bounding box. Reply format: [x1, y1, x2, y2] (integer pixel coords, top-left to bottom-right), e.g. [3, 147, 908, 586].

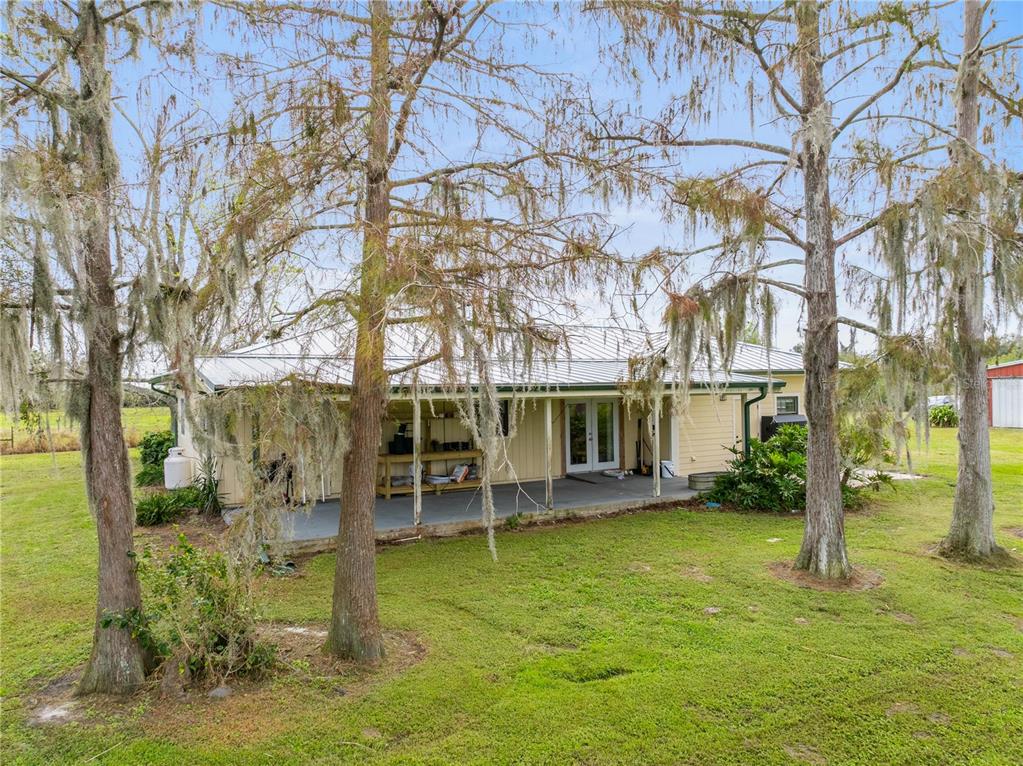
[795, 0, 850, 579]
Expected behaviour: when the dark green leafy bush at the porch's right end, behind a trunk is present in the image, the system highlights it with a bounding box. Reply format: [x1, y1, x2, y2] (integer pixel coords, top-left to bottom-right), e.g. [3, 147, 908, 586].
[707, 425, 875, 512]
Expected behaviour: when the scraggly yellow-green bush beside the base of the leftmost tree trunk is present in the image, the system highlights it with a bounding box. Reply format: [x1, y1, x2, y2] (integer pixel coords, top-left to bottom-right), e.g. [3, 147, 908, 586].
[102, 535, 276, 683]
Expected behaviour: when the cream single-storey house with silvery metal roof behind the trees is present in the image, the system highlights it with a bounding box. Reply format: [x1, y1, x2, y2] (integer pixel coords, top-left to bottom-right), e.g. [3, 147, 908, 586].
[152, 325, 803, 508]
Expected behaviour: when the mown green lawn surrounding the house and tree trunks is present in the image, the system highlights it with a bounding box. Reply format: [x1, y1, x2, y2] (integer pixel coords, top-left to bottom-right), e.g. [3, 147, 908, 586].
[0, 431, 1023, 766]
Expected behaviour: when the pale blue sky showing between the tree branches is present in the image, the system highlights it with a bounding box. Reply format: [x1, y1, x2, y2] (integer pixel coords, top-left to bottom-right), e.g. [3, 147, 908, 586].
[9, 0, 1023, 348]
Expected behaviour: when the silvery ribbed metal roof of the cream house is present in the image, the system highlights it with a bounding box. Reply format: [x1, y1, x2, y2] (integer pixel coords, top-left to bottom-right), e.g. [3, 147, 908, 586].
[171, 325, 802, 390]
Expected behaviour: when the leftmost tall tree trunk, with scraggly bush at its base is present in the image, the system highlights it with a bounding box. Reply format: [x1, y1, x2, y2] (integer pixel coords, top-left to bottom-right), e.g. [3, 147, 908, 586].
[75, 3, 145, 694]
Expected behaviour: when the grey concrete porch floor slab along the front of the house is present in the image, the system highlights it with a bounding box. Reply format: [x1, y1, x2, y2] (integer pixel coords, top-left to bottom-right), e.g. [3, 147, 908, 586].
[281, 474, 697, 552]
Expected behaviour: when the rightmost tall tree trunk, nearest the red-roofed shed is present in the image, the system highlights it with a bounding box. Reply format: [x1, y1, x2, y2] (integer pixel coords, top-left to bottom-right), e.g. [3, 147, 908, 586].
[940, 0, 1002, 559]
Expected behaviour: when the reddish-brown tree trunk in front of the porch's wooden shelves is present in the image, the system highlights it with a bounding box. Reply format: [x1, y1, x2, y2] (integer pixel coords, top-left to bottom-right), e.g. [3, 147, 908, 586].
[327, 0, 391, 663]
